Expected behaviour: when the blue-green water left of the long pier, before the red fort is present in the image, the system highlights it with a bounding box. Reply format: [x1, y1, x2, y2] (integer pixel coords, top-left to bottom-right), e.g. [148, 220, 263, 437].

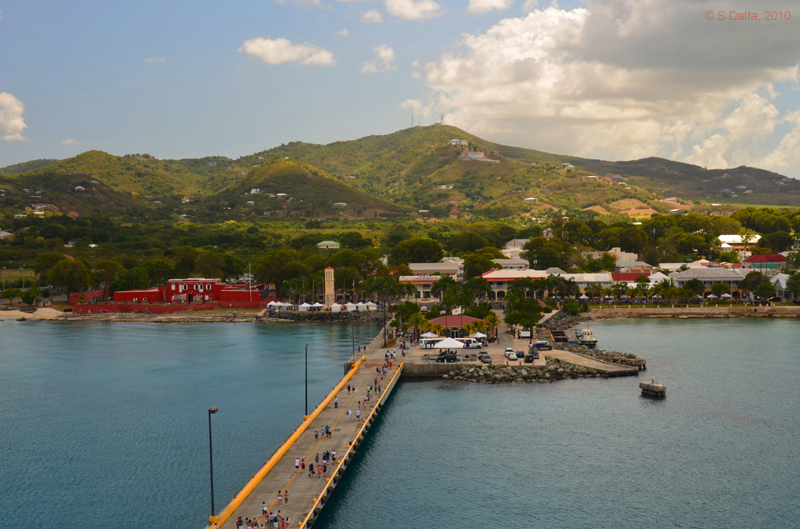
[0, 319, 378, 528]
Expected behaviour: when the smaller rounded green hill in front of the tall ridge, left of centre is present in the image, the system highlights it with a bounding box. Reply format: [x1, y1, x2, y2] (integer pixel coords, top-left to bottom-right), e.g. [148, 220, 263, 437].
[199, 158, 408, 218]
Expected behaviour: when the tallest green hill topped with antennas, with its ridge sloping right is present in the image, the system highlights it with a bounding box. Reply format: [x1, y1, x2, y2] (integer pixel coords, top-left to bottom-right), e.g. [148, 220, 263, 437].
[250, 125, 800, 217]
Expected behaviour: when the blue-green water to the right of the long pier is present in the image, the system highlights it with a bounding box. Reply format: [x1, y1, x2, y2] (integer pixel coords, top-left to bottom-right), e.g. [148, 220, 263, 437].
[315, 319, 800, 529]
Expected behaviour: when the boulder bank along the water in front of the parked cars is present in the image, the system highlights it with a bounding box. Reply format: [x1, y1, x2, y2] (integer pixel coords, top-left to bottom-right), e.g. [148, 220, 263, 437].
[442, 359, 603, 384]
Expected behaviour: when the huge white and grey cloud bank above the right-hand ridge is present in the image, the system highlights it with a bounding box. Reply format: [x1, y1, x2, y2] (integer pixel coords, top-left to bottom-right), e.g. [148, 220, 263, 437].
[415, 0, 800, 174]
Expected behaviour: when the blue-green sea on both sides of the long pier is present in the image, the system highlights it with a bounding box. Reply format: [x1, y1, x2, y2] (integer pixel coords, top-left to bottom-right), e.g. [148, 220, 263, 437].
[0, 319, 800, 529]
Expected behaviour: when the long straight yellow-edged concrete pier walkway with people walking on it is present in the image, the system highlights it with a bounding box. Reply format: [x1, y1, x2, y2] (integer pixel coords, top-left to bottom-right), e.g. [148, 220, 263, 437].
[208, 344, 402, 529]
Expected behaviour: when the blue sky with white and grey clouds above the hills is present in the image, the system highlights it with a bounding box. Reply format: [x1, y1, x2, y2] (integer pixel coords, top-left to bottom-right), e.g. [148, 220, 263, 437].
[0, 0, 800, 177]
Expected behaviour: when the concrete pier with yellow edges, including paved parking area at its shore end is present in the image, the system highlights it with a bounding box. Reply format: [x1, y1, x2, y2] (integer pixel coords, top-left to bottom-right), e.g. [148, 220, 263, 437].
[207, 316, 638, 529]
